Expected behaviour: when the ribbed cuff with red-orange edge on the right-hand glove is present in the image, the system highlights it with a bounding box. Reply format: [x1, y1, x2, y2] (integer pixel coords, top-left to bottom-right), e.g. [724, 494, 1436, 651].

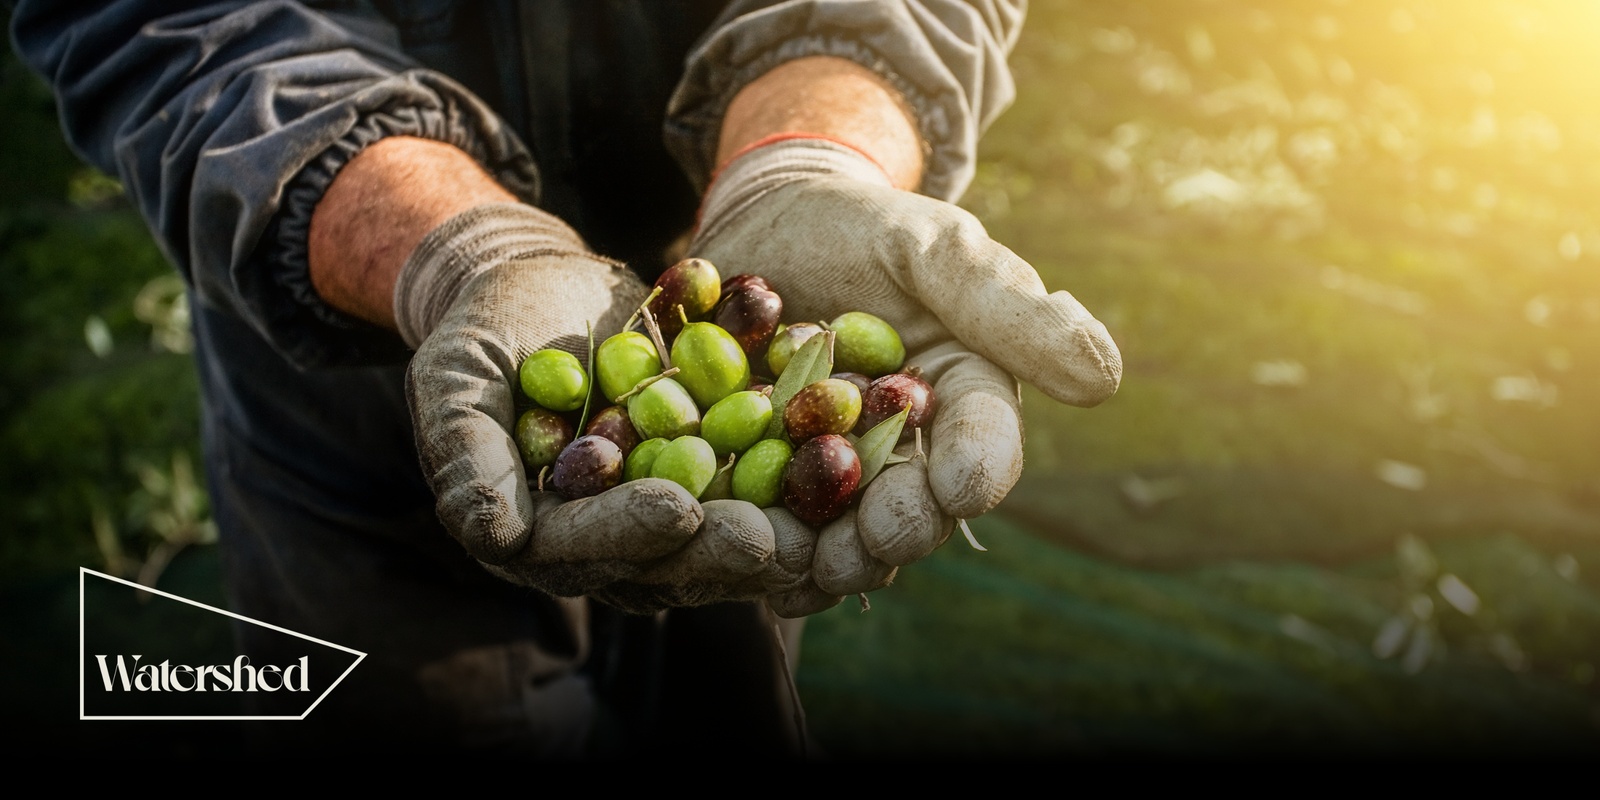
[694, 133, 894, 246]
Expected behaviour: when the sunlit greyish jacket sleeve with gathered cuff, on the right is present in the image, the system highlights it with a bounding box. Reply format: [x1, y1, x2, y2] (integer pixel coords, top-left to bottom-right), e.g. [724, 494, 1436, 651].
[666, 0, 1027, 200]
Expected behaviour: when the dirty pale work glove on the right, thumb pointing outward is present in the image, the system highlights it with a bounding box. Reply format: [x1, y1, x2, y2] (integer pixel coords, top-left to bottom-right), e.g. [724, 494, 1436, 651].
[690, 138, 1122, 614]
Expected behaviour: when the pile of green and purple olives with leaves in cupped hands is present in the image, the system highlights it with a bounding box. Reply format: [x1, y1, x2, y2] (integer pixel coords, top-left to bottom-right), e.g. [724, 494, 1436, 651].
[515, 258, 934, 525]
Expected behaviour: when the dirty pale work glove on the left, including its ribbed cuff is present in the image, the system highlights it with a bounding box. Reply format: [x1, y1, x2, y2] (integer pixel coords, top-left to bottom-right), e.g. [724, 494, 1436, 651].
[395, 203, 790, 611]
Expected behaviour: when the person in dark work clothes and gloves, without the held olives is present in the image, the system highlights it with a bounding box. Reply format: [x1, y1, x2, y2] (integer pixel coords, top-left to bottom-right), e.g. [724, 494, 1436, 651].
[11, 0, 1122, 757]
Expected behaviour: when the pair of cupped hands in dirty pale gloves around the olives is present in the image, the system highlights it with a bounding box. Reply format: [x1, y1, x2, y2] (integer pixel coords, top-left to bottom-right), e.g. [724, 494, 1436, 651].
[408, 141, 1122, 618]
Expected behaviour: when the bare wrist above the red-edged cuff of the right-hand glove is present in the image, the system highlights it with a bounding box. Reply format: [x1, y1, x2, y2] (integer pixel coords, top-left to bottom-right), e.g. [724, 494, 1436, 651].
[717, 56, 923, 189]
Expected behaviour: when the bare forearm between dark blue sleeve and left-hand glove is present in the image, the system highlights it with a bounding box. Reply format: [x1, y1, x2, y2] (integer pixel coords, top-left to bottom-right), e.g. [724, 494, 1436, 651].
[309, 136, 517, 330]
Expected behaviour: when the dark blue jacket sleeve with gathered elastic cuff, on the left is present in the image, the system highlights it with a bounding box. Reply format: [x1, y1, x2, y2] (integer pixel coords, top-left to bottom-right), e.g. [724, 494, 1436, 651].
[11, 0, 538, 368]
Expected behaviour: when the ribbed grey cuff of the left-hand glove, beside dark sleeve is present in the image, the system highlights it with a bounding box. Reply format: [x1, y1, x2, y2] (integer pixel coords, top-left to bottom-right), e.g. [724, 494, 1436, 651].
[394, 203, 606, 349]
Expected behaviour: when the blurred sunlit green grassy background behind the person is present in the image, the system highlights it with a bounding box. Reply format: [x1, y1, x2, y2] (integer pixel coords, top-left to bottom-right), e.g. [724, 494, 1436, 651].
[0, 0, 1600, 757]
